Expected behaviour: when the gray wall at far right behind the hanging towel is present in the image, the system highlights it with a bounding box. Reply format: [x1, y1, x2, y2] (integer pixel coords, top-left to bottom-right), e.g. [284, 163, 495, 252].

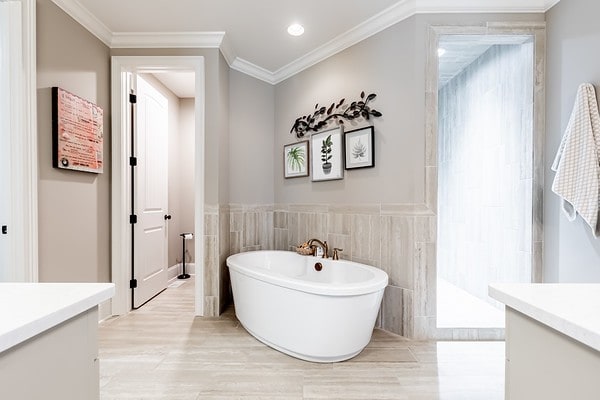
[544, 0, 600, 282]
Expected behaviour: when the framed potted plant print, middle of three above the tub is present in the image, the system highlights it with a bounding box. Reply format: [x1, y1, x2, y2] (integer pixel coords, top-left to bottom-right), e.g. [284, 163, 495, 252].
[310, 127, 344, 182]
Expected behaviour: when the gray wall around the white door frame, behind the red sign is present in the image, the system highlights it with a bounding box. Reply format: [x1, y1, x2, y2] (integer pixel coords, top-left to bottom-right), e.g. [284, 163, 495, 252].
[37, 0, 229, 282]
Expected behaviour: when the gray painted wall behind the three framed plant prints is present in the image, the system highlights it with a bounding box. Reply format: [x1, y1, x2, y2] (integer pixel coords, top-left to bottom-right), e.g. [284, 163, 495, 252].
[274, 14, 544, 204]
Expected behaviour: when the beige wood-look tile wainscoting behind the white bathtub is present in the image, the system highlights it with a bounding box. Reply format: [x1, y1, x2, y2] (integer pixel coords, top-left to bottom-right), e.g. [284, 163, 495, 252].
[209, 204, 437, 338]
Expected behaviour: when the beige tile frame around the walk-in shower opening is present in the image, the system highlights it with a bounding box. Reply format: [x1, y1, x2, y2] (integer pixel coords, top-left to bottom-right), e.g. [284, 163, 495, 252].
[424, 21, 546, 340]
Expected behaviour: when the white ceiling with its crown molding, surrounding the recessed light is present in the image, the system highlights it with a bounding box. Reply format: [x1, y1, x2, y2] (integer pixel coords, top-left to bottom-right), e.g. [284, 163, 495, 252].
[53, 0, 559, 84]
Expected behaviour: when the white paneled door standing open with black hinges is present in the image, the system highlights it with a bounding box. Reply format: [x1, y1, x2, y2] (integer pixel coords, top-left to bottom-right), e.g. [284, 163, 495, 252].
[133, 76, 169, 308]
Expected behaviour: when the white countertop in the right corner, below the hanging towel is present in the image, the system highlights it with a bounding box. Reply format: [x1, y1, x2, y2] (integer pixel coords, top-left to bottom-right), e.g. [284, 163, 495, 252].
[489, 283, 600, 351]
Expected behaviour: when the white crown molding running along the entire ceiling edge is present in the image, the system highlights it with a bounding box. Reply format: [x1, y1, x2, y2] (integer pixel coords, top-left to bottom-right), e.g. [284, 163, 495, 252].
[52, 0, 560, 85]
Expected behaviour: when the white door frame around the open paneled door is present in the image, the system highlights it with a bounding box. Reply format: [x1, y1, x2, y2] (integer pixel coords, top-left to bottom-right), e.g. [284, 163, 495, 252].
[111, 56, 205, 316]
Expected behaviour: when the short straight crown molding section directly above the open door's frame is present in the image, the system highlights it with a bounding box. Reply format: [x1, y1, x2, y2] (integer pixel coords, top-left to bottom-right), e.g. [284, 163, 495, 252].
[110, 32, 225, 49]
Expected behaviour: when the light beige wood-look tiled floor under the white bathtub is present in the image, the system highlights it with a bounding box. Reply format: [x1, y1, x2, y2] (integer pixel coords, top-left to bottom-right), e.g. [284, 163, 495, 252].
[100, 281, 504, 400]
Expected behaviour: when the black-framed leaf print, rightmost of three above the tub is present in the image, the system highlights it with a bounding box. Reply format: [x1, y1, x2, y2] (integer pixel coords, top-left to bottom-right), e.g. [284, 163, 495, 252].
[344, 126, 375, 169]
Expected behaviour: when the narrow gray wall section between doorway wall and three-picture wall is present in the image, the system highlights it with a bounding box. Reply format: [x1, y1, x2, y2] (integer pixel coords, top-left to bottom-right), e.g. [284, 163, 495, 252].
[229, 70, 280, 204]
